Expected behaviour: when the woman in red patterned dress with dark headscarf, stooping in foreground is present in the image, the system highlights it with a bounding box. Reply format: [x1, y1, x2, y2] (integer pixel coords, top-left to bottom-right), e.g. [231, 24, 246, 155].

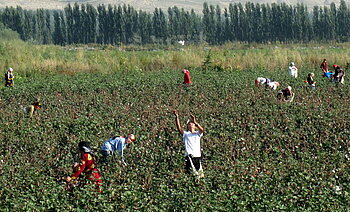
[66, 142, 102, 192]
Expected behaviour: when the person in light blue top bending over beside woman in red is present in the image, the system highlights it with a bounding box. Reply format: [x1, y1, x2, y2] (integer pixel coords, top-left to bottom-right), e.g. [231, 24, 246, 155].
[101, 134, 136, 165]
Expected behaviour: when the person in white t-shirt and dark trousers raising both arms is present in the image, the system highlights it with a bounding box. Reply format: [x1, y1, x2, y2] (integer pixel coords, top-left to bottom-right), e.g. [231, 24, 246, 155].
[174, 110, 204, 179]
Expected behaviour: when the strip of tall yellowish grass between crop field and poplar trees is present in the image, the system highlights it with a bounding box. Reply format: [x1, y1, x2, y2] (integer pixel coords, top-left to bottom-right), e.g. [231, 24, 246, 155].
[0, 36, 350, 75]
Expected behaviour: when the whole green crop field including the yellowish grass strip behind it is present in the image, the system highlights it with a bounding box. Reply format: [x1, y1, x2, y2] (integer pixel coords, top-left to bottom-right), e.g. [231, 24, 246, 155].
[0, 36, 350, 211]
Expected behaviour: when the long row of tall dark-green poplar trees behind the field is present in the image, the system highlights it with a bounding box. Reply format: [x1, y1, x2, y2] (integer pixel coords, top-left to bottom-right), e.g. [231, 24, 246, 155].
[0, 0, 350, 45]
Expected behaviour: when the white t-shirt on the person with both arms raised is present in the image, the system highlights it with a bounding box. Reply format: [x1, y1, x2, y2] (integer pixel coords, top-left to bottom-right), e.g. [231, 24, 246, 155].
[182, 131, 203, 157]
